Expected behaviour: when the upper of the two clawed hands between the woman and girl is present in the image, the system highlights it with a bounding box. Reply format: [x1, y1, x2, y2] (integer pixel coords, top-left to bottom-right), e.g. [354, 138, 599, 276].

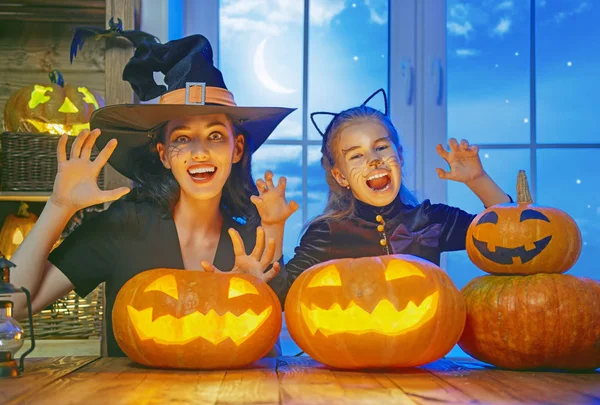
[250, 171, 298, 226]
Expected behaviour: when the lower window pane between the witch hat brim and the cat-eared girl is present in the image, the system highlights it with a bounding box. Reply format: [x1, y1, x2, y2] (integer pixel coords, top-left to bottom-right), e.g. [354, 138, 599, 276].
[252, 145, 302, 262]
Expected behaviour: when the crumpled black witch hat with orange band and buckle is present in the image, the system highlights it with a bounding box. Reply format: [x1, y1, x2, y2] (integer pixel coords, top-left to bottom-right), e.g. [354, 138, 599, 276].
[90, 35, 295, 178]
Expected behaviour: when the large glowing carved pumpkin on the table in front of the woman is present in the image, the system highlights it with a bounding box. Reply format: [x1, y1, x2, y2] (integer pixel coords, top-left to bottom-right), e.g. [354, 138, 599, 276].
[112, 269, 282, 369]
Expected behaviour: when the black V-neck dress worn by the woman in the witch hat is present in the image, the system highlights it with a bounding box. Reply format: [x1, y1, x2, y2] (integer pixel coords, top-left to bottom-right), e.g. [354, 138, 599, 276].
[48, 200, 289, 357]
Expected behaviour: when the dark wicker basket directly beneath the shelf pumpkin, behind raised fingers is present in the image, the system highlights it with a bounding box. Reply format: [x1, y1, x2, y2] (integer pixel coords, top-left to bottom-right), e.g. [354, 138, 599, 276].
[0, 132, 104, 192]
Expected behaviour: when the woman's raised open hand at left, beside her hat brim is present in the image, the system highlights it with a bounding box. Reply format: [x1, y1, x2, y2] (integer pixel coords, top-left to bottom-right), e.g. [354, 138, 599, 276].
[50, 129, 130, 214]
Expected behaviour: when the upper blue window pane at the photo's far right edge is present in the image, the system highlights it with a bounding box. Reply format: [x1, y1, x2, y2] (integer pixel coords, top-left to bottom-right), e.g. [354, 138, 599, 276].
[536, 1, 600, 143]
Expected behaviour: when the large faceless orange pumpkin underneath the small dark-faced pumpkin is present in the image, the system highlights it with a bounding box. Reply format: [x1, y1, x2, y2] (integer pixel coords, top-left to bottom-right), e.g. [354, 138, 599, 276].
[458, 274, 600, 370]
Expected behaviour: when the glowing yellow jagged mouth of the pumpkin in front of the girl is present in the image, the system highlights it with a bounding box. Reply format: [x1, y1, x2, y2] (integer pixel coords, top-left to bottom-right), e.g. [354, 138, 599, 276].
[301, 291, 439, 336]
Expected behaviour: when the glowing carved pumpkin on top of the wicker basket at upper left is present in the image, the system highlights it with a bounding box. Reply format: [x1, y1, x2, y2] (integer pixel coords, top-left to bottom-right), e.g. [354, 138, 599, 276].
[4, 70, 104, 136]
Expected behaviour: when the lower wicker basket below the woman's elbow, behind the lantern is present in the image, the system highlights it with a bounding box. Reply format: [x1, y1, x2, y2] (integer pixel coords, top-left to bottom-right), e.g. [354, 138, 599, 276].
[21, 283, 104, 340]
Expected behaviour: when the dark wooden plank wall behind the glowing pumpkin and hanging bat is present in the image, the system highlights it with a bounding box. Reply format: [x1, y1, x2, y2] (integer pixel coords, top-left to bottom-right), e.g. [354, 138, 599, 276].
[0, 0, 105, 129]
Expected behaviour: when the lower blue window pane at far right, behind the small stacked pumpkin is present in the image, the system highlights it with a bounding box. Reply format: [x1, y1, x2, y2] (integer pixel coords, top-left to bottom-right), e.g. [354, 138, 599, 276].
[535, 149, 600, 280]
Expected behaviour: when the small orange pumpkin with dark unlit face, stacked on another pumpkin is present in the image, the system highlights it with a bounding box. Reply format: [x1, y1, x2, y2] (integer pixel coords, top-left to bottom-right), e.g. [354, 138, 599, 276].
[466, 170, 582, 274]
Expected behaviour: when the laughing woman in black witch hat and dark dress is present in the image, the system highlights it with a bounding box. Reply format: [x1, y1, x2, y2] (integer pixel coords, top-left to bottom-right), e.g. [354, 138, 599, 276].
[12, 35, 298, 356]
